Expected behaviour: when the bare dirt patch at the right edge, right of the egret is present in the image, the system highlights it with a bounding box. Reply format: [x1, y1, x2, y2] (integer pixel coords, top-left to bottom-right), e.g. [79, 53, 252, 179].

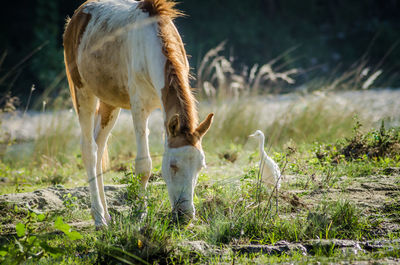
[280, 175, 400, 236]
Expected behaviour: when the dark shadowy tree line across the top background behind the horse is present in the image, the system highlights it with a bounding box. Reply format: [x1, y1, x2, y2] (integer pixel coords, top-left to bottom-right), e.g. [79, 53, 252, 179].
[0, 0, 400, 104]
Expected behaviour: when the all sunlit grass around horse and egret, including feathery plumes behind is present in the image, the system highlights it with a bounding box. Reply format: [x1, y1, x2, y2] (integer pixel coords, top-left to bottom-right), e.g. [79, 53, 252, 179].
[0, 44, 400, 264]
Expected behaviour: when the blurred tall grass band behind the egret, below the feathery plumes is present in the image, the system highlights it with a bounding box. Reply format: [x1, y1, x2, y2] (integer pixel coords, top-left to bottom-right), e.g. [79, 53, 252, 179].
[200, 94, 370, 151]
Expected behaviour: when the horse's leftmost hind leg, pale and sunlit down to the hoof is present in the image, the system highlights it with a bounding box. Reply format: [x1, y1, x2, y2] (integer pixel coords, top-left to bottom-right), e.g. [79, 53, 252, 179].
[76, 90, 106, 226]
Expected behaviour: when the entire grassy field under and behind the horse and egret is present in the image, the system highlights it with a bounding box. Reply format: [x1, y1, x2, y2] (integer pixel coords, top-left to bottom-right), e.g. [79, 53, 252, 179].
[0, 83, 400, 264]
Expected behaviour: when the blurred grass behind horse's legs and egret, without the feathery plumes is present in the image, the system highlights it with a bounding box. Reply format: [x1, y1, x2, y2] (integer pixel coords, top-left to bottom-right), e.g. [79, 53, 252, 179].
[0, 89, 369, 194]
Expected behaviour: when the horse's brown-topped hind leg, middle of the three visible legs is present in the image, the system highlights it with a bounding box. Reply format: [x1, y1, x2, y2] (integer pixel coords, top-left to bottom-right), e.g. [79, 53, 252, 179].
[94, 102, 120, 221]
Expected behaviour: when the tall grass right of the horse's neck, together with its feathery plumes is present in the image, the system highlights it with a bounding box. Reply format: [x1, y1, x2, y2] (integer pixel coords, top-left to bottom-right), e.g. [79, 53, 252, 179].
[197, 42, 390, 151]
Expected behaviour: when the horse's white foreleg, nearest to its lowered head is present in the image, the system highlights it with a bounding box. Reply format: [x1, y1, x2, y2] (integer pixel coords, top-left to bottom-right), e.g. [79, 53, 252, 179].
[131, 100, 151, 188]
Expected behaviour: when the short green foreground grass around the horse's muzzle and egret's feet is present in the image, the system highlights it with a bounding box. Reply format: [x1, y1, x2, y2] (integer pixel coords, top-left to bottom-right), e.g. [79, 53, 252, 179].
[0, 134, 397, 264]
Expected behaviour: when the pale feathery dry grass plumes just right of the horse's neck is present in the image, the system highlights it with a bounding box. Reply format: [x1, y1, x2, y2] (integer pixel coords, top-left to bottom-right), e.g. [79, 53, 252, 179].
[197, 42, 299, 102]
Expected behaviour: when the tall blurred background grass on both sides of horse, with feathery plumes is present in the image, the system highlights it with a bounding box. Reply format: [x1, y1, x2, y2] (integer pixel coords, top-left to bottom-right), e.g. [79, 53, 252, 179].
[0, 43, 394, 189]
